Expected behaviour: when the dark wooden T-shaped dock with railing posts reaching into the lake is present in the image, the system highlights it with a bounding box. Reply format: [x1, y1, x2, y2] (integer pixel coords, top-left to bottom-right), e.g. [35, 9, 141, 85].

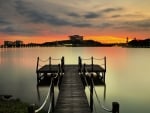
[33, 57, 117, 113]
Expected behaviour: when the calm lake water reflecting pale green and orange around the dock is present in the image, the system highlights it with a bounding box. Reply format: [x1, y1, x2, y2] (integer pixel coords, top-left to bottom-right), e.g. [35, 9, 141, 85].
[0, 47, 150, 113]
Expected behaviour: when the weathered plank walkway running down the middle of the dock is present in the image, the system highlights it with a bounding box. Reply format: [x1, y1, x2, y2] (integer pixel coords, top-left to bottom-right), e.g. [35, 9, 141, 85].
[54, 65, 91, 113]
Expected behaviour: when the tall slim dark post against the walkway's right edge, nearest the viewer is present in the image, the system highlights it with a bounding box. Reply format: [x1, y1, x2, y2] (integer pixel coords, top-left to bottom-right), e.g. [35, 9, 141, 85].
[90, 74, 93, 112]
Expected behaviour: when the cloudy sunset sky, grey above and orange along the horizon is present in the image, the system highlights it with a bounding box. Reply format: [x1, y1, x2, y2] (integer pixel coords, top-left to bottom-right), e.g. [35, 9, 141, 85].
[0, 0, 150, 44]
